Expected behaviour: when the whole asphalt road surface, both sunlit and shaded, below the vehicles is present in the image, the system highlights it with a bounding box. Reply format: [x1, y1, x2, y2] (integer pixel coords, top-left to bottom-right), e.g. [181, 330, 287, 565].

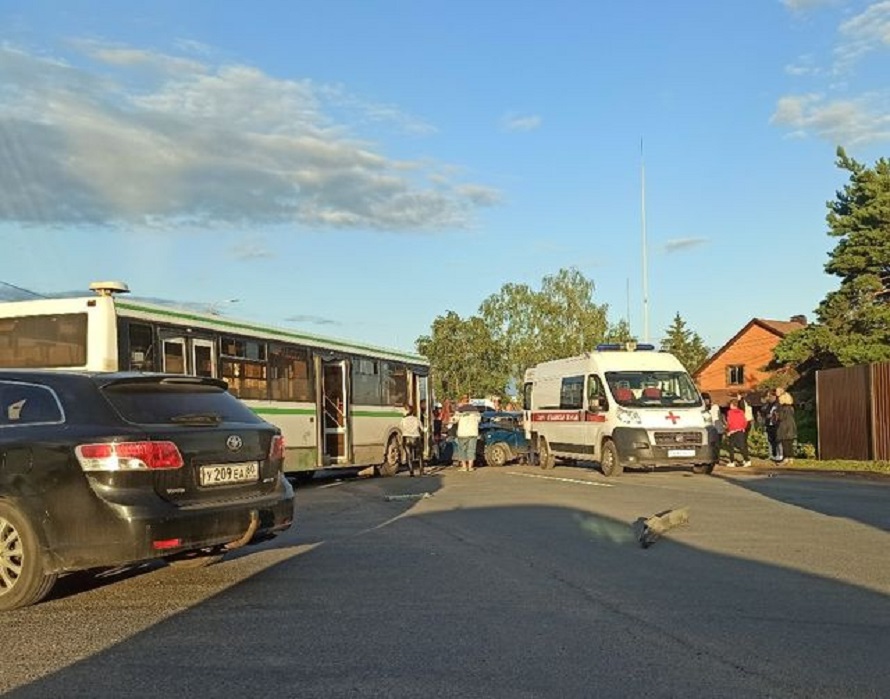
[0, 466, 890, 699]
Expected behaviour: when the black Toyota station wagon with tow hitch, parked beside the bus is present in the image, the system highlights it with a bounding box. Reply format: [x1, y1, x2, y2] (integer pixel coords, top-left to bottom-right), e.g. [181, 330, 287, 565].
[0, 370, 294, 610]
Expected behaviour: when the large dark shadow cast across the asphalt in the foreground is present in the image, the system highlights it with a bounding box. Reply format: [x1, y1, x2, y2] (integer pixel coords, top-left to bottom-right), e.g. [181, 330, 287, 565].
[4, 474, 890, 699]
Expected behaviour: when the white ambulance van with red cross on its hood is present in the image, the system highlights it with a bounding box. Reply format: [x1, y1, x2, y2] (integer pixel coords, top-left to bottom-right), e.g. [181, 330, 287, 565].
[523, 343, 717, 476]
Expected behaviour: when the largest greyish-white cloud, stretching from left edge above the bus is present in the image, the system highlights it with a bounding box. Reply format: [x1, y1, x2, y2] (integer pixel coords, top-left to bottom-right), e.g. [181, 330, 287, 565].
[0, 42, 498, 230]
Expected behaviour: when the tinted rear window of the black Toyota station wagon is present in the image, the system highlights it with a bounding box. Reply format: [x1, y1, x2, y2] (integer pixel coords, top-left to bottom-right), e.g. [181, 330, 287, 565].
[101, 381, 263, 424]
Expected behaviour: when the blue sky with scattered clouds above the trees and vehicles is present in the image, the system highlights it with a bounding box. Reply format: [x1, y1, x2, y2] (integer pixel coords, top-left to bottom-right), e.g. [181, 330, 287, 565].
[0, 0, 890, 350]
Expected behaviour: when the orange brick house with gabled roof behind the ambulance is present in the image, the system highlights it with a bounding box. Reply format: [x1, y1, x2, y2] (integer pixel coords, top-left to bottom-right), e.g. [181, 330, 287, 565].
[692, 316, 807, 406]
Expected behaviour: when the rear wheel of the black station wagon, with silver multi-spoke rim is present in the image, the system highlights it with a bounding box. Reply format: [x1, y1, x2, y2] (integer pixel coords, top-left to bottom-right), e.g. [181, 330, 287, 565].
[0, 502, 58, 611]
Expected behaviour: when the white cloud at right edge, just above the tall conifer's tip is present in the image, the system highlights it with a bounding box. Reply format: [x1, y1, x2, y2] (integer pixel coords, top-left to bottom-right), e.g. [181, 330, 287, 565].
[770, 92, 890, 146]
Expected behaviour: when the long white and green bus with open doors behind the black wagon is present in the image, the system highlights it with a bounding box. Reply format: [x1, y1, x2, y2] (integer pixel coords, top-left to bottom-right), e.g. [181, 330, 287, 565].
[0, 282, 431, 480]
